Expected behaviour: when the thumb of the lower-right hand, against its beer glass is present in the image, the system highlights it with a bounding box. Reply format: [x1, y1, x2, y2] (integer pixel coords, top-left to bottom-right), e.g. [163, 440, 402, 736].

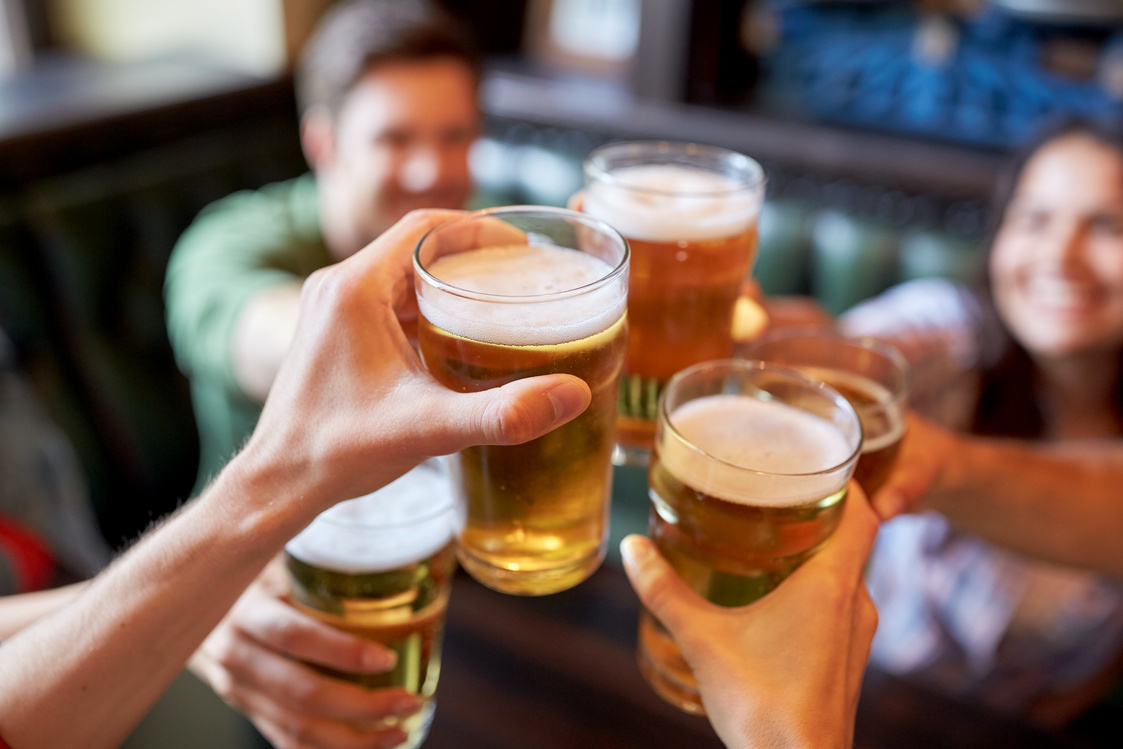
[620, 533, 706, 637]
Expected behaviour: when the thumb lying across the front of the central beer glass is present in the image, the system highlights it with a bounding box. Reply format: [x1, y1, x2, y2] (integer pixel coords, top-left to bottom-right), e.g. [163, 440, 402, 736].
[449, 374, 593, 445]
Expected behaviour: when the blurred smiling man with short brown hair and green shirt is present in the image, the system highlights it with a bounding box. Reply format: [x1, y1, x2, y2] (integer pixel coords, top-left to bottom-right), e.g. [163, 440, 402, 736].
[165, 0, 480, 493]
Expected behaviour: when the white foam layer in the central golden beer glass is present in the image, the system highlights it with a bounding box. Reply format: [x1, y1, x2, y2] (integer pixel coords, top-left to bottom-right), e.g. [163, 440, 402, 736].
[418, 245, 627, 346]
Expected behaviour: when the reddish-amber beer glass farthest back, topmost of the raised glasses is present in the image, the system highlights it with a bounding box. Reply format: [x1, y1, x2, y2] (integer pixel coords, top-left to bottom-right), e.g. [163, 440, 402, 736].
[583, 141, 765, 465]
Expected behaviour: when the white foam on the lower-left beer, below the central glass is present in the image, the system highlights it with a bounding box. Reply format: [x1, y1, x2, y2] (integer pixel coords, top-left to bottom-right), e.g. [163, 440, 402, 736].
[285, 465, 454, 575]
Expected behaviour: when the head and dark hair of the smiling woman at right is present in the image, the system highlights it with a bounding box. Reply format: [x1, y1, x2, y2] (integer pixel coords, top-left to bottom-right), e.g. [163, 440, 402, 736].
[973, 120, 1123, 439]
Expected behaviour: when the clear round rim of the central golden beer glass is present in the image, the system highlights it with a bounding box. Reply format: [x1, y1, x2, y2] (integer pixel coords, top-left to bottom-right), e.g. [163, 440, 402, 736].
[413, 205, 631, 304]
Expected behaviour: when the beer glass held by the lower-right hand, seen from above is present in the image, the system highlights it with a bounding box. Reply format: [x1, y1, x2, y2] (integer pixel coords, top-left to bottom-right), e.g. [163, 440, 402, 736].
[638, 359, 861, 714]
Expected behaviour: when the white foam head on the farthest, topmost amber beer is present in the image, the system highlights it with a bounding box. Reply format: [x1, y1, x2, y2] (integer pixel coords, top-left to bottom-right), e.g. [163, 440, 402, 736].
[583, 164, 760, 241]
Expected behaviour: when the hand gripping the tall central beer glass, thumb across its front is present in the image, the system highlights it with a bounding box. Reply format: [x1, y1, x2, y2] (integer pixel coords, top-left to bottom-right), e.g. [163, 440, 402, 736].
[236, 210, 591, 522]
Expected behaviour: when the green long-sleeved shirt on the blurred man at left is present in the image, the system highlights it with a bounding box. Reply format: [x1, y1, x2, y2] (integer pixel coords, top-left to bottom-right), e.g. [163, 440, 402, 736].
[164, 174, 334, 493]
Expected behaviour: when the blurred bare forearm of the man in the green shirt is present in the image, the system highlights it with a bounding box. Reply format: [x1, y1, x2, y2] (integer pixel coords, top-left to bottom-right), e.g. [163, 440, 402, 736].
[230, 281, 301, 403]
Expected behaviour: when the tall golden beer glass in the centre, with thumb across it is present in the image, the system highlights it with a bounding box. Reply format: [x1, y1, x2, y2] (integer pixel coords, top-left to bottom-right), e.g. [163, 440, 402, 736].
[414, 207, 628, 595]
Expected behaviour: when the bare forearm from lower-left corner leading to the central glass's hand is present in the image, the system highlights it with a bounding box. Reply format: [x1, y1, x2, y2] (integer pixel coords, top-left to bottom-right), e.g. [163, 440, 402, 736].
[0, 453, 321, 749]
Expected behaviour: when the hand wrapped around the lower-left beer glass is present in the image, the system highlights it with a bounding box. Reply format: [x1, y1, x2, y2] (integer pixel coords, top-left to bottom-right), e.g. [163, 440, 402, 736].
[188, 556, 421, 749]
